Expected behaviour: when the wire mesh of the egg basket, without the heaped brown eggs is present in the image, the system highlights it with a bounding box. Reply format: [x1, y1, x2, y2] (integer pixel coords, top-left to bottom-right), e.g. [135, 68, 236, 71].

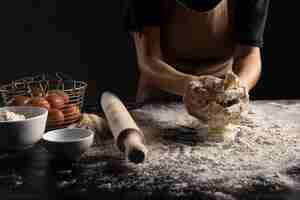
[0, 72, 87, 130]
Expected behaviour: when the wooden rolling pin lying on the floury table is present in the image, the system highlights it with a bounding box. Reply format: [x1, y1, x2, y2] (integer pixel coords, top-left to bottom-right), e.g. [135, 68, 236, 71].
[101, 92, 148, 163]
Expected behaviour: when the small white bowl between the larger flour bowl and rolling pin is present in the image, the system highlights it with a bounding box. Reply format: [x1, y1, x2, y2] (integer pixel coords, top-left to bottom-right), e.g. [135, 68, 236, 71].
[43, 128, 94, 161]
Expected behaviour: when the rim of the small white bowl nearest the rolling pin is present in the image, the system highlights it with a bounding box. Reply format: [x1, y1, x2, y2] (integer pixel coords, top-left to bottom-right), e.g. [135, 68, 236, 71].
[42, 128, 95, 143]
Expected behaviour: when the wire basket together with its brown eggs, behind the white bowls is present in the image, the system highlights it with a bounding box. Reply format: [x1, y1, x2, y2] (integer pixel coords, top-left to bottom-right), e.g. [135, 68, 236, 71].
[0, 73, 87, 130]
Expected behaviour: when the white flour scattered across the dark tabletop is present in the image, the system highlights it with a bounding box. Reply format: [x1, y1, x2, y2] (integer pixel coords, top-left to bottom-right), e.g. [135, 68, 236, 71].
[81, 101, 300, 199]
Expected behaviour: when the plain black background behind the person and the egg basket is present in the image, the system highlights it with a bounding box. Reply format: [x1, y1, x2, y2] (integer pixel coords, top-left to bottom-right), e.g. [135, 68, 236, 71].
[0, 0, 300, 106]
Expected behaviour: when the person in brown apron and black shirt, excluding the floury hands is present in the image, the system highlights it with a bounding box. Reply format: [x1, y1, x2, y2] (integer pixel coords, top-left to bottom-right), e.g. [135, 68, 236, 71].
[124, 0, 269, 102]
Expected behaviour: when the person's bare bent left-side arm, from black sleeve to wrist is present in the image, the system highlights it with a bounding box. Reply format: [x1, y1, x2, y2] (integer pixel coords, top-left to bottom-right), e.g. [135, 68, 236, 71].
[132, 27, 197, 96]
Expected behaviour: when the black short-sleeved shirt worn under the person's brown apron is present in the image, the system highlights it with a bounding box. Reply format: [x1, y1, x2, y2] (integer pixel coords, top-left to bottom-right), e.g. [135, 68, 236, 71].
[124, 0, 270, 47]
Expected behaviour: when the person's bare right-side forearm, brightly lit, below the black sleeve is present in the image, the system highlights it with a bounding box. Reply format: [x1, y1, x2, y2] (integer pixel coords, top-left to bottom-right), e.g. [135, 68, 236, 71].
[233, 45, 261, 91]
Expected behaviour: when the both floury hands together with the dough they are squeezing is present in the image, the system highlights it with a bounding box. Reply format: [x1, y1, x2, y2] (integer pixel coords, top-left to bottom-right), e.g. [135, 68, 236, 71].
[183, 72, 249, 128]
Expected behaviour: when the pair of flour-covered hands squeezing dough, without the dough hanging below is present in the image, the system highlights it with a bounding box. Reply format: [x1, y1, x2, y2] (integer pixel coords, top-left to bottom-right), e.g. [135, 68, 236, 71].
[183, 73, 249, 122]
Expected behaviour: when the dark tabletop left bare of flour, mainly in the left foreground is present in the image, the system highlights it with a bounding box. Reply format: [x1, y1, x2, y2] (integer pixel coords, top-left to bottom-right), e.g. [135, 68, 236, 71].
[0, 101, 300, 200]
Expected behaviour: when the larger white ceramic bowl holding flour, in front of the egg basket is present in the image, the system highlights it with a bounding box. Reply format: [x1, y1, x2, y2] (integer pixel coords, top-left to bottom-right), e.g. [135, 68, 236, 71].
[0, 106, 48, 151]
